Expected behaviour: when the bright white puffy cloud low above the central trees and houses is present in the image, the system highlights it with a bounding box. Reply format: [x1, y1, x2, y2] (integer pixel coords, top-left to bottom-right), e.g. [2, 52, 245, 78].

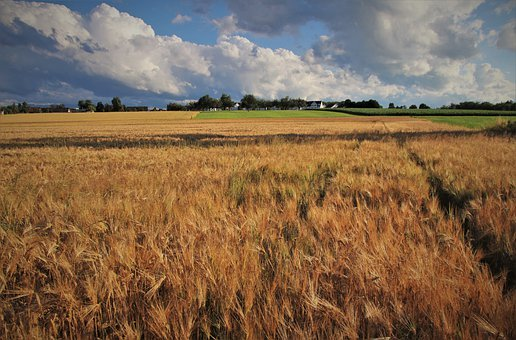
[211, 36, 404, 99]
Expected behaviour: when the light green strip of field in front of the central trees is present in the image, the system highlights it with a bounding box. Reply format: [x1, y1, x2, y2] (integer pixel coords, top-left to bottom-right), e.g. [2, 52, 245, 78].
[195, 110, 351, 119]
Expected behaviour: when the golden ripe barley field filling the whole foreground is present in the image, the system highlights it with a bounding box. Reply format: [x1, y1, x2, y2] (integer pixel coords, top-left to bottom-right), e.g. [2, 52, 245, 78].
[0, 113, 516, 339]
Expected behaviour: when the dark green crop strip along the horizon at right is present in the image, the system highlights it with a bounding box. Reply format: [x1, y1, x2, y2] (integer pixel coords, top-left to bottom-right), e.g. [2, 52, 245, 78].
[327, 108, 516, 116]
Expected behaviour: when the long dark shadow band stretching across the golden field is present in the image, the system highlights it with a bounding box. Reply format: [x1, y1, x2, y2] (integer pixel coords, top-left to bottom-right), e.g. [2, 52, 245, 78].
[0, 131, 492, 149]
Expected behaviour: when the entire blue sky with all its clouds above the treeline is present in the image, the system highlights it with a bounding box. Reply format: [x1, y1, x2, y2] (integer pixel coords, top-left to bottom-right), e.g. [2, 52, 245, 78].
[0, 0, 516, 107]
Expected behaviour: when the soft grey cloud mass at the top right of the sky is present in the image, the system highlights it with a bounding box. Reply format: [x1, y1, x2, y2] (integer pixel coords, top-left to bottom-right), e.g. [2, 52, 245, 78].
[228, 0, 482, 70]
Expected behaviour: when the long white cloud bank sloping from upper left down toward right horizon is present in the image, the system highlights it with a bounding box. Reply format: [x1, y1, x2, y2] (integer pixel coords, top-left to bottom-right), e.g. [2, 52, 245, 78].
[0, 2, 404, 103]
